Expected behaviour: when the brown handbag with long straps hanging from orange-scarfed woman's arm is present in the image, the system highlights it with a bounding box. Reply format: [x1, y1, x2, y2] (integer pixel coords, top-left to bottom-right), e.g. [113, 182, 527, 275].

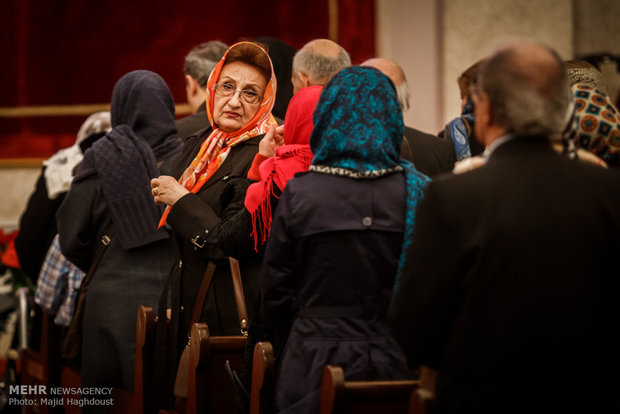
[174, 257, 248, 398]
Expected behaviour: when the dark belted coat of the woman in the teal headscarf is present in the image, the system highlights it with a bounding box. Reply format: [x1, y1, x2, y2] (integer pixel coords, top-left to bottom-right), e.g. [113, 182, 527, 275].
[261, 172, 410, 413]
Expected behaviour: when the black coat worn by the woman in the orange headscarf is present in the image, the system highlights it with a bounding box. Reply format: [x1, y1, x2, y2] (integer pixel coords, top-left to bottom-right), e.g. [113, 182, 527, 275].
[156, 127, 262, 407]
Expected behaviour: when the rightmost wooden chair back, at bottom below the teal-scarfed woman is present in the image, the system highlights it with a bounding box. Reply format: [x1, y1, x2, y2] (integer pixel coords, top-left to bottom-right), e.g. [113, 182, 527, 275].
[319, 365, 419, 414]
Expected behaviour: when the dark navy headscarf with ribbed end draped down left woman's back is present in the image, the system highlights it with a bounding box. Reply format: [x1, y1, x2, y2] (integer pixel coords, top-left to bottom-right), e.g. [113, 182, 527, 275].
[74, 70, 181, 250]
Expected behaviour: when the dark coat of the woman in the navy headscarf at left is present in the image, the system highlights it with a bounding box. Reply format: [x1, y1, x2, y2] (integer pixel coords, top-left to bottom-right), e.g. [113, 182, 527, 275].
[57, 176, 173, 391]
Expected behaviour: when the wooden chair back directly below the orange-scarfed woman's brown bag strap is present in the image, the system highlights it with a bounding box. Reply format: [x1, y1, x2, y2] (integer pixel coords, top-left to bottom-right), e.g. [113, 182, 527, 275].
[185, 323, 246, 414]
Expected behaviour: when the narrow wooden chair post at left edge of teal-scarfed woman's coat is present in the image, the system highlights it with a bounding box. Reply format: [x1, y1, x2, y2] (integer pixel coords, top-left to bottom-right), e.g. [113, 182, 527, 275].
[250, 342, 275, 414]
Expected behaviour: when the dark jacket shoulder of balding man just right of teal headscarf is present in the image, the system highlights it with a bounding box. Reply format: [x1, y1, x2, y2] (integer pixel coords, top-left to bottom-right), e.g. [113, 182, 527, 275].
[403, 126, 456, 177]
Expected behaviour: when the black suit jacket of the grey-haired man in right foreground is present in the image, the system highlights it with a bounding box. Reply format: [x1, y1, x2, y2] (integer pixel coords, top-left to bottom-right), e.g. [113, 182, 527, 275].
[391, 138, 620, 413]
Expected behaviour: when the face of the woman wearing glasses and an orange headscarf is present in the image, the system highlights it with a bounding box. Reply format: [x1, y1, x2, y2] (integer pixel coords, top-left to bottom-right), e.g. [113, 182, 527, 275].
[213, 61, 267, 132]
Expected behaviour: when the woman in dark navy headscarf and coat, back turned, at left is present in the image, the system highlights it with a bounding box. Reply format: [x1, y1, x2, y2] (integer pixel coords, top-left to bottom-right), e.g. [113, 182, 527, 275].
[57, 70, 181, 409]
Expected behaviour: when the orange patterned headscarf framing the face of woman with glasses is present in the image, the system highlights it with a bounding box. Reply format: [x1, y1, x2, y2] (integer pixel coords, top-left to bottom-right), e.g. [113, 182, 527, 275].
[159, 42, 278, 227]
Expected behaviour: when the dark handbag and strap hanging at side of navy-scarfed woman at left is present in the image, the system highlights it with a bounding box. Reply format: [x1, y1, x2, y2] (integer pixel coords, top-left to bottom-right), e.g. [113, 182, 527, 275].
[61, 229, 113, 367]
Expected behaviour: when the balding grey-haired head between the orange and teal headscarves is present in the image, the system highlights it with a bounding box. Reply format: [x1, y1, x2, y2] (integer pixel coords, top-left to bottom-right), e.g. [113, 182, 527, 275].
[291, 39, 351, 93]
